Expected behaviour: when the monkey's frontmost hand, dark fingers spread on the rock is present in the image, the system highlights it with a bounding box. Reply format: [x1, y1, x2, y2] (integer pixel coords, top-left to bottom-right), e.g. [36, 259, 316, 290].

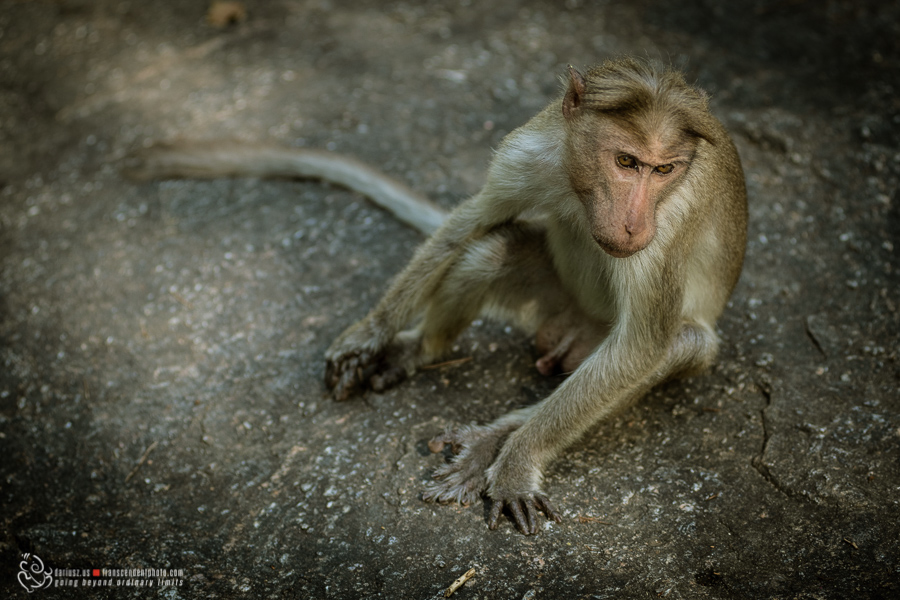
[487, 454, 562, 535]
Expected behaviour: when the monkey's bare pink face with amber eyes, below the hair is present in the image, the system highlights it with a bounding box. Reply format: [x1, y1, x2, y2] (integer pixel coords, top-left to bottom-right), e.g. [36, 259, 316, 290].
[569, 121, 696, 258]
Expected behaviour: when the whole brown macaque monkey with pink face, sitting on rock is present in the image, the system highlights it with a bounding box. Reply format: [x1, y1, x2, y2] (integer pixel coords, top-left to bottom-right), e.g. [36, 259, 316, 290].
[126, 58, 747, 535]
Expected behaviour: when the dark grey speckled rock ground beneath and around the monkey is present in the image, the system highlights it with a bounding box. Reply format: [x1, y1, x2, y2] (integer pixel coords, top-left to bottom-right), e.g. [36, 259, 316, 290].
[0, 0, 900, 600]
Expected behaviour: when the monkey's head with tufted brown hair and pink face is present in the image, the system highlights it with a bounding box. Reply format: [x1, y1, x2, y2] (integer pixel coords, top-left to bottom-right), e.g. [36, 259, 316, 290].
[562, 59, 716, 258]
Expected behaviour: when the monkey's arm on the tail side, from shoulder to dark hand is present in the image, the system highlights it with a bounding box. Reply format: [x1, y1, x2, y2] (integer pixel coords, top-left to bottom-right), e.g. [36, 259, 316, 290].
[325, 115, 569, 400]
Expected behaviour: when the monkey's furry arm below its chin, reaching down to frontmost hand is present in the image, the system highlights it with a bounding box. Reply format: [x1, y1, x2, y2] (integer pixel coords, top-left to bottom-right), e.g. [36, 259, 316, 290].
[487, 260, 688, 534]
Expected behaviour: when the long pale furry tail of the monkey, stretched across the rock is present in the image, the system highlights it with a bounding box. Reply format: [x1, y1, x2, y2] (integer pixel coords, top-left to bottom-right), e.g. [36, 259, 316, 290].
[124, 141, 447, 235]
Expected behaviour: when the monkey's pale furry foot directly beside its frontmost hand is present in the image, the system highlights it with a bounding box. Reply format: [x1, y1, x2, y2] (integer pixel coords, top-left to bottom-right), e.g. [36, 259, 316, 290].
[422, 426, 511, 506]
